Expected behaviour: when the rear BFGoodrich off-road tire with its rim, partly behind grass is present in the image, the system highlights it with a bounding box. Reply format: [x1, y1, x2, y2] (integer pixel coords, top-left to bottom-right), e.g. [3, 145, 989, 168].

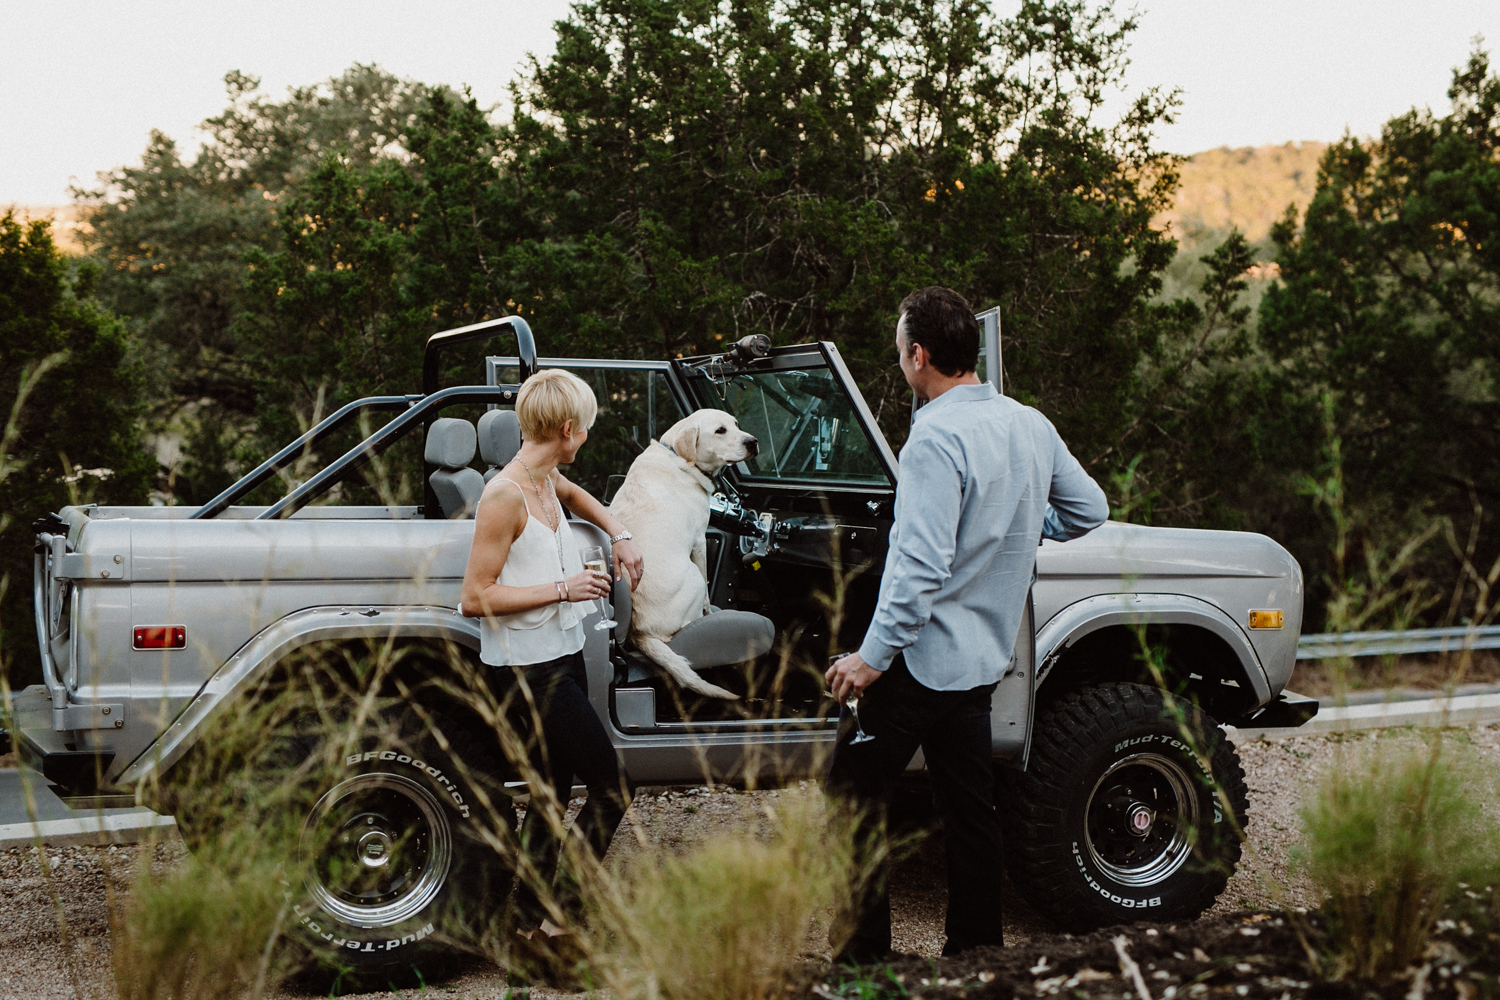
[285, 716, 513, 990]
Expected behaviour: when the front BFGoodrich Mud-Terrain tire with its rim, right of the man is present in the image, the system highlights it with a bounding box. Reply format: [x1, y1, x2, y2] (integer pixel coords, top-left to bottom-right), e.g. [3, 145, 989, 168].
[1001, 684, 1248, 931]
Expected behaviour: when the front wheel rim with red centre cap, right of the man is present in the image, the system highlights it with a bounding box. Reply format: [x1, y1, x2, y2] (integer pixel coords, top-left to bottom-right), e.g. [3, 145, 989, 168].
[1085, 754, 1199, 888]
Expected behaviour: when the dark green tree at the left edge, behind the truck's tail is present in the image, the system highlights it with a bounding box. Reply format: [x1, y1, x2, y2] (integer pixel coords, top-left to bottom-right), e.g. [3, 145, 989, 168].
[0, 211, 156, 687]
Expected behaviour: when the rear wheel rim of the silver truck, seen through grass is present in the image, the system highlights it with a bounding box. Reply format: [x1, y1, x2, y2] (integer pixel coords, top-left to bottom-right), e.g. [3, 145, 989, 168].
[302, 774, 453, 928]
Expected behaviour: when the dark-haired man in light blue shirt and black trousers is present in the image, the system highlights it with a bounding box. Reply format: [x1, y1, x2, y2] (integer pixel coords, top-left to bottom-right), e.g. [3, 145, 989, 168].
[828, 288, 1109, 963]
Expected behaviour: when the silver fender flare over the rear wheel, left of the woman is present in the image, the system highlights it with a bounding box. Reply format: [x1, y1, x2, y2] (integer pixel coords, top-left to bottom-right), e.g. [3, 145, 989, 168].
[117, 604, 479, 786]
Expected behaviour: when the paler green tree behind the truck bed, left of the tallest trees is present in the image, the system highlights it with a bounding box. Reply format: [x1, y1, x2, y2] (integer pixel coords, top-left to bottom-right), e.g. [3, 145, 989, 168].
[74, 64, 428, 502]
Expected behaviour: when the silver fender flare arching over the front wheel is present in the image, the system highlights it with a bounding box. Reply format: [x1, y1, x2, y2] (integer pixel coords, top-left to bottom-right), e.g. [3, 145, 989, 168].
[1037, 594, 1272, 711]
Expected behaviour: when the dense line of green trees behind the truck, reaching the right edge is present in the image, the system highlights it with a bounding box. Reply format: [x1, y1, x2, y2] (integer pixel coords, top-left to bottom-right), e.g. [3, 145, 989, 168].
[2, 0, 1500, 689]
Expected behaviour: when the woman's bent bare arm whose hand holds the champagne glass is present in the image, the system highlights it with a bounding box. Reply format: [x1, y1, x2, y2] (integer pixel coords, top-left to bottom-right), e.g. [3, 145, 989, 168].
[462, 487, 609, 618]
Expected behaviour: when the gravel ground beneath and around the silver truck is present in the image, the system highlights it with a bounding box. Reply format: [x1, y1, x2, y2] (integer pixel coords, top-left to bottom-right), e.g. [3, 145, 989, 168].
[0, 726, 1500, 1000]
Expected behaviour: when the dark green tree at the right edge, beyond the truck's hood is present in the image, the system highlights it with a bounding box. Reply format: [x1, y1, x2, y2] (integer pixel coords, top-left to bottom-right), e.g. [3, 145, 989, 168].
[1259, 48, 1500, 626]
